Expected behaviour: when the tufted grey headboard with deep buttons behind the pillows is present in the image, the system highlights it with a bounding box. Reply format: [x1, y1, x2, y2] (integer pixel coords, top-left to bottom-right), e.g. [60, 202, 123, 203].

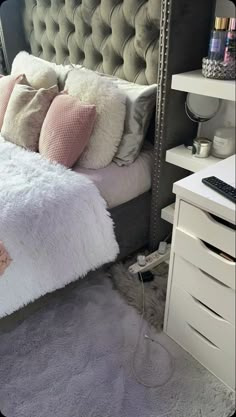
[1, 0, 162, 84]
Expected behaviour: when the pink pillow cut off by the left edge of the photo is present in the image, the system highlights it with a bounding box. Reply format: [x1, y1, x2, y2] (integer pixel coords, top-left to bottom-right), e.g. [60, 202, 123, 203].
[0, 74, 25, 130]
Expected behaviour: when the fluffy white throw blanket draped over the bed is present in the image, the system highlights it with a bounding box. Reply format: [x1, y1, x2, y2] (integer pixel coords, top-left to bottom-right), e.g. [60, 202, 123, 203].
[0, 137, 119, 317]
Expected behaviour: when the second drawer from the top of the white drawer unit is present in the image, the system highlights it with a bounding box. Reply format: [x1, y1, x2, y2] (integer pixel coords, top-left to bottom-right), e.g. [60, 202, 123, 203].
[174, 228, 236, 290]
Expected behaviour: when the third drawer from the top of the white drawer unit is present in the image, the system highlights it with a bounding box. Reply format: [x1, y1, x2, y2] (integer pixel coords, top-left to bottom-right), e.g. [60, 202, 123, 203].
[172, 255, 235, 325]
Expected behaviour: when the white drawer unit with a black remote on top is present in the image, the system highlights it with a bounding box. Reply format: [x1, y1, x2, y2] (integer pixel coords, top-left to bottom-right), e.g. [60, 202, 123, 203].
[164, 156, 236, 389]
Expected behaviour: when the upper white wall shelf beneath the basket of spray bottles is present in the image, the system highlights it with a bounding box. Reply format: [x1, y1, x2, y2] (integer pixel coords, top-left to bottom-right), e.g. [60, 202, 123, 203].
[172, 70, 236, 102]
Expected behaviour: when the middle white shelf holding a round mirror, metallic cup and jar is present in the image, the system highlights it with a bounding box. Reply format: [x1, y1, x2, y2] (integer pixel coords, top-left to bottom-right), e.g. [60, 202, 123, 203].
[166, 93, 236, 172]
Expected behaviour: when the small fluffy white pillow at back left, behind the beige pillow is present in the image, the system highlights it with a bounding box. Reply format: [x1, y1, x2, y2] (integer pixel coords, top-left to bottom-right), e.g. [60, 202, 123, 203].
[11, 51, 57, 90]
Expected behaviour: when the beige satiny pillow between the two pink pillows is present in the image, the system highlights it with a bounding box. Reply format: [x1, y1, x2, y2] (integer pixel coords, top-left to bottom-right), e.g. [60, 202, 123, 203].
[1, 84, 58, 151]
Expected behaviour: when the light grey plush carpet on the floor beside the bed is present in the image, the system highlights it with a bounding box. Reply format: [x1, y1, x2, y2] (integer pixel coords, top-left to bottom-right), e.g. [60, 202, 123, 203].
[0, 272, 234, 417]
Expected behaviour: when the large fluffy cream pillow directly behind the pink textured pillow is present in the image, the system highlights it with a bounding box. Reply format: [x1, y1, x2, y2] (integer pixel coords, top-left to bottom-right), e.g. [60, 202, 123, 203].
[65, 69, 126, 169]
